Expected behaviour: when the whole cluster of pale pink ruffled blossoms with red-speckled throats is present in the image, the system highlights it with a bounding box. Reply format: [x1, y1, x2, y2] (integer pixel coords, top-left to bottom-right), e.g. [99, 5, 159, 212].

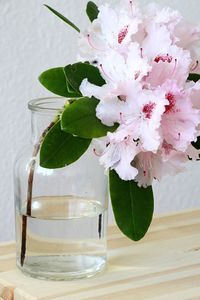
[79, 0, 200, 187]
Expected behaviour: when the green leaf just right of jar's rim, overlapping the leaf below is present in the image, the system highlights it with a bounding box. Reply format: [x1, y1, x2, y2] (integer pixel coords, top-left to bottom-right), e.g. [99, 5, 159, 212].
[61, 97, 118, 139]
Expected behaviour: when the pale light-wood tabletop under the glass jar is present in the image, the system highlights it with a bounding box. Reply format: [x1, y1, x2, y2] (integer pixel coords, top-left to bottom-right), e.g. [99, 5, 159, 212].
[0, 210, 200, 300]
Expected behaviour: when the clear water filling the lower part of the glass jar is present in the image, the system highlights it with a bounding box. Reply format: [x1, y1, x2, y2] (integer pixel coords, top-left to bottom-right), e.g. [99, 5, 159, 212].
[16, 196, 107, 280]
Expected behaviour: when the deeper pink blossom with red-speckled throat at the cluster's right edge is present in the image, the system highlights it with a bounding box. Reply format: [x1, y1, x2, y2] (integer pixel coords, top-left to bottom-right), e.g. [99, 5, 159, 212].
[161, 81, 200, 152]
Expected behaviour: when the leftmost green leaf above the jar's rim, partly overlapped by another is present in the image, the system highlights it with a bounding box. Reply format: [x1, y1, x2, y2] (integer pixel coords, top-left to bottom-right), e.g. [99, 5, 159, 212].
[39, 68, 79, 98]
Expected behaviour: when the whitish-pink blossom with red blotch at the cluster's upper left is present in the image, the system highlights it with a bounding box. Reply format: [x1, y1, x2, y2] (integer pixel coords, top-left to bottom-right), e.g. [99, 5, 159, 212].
[79, 0, 141, 62]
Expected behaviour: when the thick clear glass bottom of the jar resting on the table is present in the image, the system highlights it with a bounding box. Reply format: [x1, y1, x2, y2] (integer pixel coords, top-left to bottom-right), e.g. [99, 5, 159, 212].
[17, 255, 106, 281]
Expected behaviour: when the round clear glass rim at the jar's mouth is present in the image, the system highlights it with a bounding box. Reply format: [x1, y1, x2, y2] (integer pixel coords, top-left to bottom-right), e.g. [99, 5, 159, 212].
[28, 96, 68, 114]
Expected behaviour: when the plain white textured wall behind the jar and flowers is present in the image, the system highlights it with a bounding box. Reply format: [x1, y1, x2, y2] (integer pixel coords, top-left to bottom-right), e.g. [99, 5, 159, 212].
[0, 0, 200, 241]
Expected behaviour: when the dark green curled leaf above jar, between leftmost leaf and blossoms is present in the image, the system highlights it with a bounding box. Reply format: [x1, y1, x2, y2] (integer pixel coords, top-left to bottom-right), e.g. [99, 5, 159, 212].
[64, 63, 106, 95]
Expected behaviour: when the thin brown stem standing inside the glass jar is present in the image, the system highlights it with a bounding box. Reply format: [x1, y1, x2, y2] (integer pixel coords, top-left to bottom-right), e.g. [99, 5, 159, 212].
[20, 121, 56, 267]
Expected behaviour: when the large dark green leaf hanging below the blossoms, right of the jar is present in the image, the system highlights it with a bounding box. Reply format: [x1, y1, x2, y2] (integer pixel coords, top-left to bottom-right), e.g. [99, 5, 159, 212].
[110, 171, 154, 241]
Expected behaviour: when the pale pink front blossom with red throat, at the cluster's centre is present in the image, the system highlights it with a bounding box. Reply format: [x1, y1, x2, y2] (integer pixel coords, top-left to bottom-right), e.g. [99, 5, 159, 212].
[122, 87, 168, 151]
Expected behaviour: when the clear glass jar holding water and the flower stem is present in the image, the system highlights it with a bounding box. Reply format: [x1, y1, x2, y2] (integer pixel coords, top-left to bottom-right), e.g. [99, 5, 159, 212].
[14, 98, 108, 280]
